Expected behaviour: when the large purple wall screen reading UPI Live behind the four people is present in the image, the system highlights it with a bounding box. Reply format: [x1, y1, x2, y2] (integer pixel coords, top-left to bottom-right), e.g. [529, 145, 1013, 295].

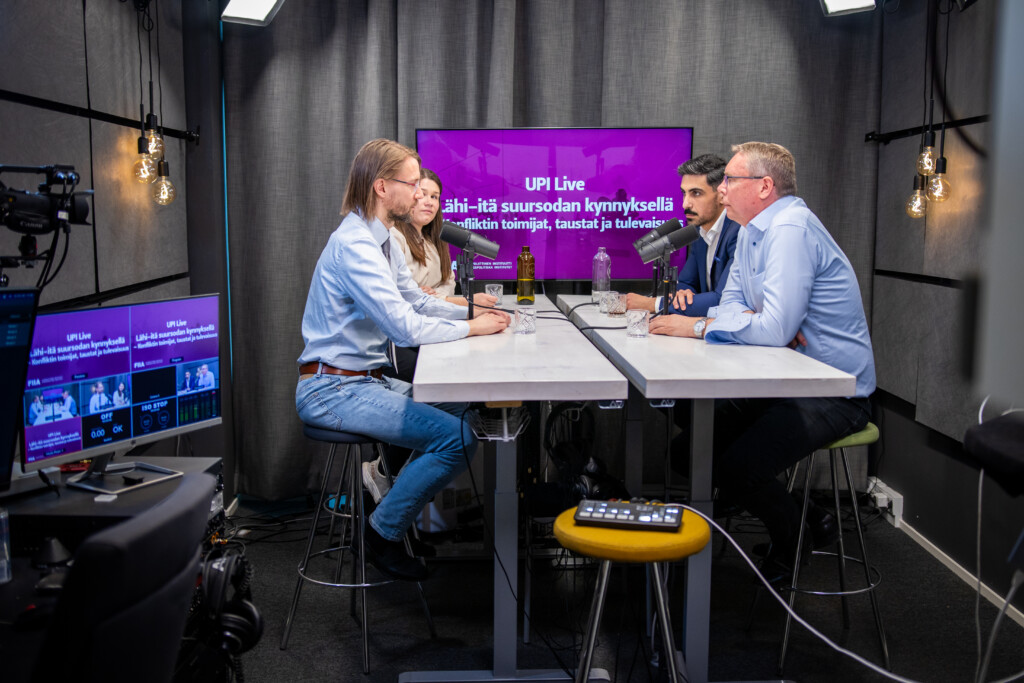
[416, 128, 693, 280]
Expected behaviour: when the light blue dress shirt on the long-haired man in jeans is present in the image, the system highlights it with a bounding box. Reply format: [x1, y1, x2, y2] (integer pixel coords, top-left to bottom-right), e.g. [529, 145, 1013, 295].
[298, 212, 469, 370]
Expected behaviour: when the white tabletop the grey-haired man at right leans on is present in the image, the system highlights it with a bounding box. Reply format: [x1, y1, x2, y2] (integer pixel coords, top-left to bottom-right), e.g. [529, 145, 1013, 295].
[558, 295, 857, 398]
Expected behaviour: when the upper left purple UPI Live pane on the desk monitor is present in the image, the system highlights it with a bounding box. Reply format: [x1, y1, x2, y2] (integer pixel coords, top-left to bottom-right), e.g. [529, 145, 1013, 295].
[26, 306, 130, 389]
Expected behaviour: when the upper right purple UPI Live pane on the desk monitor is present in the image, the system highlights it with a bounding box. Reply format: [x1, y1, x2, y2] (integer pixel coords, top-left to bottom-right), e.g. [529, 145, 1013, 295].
[131, 297, 218, 371]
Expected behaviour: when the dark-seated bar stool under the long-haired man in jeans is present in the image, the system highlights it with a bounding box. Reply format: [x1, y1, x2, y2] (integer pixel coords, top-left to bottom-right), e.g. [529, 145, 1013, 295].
[281, 425, 437, 674]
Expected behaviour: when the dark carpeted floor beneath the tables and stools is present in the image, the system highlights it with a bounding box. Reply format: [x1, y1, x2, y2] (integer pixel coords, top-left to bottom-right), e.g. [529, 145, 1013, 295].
[232, 502, 1024, 683]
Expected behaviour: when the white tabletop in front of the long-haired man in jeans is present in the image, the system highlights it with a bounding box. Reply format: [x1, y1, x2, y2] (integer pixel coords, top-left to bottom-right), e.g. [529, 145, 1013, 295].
[413, 296, 629, 402]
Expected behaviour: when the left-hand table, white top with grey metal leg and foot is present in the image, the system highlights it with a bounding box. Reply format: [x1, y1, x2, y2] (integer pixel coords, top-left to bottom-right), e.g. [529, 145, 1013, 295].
[398, 297, 627, 683]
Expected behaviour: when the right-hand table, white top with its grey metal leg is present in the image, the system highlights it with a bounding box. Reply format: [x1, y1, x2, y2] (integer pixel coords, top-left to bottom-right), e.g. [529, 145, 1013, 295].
[558, 295, 857, 683]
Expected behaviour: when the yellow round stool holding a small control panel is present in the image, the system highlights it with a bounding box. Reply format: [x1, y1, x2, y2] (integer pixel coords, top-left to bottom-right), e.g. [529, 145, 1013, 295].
[555, 508, 711, 683]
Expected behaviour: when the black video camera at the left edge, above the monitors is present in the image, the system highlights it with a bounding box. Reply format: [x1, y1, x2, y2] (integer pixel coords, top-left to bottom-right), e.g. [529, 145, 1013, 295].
[0, 165, 92, 288]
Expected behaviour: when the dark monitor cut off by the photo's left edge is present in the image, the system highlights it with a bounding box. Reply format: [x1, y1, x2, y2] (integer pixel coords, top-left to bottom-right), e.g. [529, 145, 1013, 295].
[0, 289, 39, 492]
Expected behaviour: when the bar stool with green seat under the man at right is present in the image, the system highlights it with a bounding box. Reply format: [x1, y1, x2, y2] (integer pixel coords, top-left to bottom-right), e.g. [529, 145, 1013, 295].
[778, 422, 889, 676]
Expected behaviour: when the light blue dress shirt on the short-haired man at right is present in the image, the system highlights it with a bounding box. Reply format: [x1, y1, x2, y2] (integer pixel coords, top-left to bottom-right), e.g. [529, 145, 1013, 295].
[705, 197, 874, 396]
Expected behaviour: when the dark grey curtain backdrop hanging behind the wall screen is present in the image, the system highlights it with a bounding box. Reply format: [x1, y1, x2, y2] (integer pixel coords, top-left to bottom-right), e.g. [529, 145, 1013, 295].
[224, 0, 881, 499]
